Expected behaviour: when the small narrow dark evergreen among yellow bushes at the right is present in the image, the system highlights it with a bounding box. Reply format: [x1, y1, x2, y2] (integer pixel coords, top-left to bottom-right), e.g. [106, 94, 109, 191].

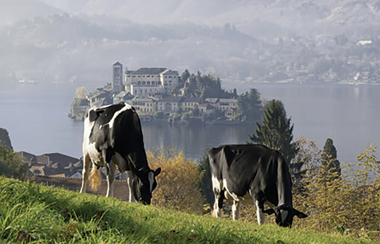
[321, 138, 341, 180]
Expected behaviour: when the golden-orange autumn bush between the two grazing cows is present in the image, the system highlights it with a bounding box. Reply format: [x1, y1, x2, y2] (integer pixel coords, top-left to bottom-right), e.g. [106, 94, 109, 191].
[147, 152, 204, 214]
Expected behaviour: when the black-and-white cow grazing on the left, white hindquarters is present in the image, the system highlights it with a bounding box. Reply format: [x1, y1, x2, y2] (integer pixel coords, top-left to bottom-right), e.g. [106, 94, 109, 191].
[80, 103, 161, 204]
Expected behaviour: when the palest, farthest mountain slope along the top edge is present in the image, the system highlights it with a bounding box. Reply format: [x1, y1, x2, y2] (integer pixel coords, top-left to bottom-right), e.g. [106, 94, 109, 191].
[41, 0, 380, 36]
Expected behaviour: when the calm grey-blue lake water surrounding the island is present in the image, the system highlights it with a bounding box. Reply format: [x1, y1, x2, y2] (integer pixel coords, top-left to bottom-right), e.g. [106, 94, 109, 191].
[0, 83, 380, 162]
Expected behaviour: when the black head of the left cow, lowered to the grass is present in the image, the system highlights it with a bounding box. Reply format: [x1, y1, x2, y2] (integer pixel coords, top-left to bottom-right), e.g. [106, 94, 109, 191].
[132, 168, 161, 204]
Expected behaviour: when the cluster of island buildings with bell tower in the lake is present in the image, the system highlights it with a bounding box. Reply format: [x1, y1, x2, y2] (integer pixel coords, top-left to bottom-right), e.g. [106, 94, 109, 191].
[69, 62, 238, 123]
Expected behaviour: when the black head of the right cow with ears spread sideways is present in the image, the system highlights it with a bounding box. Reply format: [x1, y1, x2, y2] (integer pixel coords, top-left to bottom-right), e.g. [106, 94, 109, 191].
[264, 205, 307, 227]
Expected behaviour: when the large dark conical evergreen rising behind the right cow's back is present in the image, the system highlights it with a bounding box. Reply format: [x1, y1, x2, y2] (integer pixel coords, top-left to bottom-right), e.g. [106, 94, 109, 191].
[247, 99, 302, 166]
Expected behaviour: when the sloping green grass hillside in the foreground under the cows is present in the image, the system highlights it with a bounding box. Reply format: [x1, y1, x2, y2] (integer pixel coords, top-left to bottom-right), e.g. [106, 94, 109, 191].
[0, 177, 373, 243]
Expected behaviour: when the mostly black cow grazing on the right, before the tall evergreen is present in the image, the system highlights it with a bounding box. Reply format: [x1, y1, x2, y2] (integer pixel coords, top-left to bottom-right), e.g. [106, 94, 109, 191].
[208, 144, 307, 227]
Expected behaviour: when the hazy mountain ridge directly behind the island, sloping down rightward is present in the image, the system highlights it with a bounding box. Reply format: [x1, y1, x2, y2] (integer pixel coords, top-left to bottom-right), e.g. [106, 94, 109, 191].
[0, 14, 256, 84]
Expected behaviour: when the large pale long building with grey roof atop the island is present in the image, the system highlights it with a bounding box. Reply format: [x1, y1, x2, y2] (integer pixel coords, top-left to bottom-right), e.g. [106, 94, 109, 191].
[125, 68, 178, 98]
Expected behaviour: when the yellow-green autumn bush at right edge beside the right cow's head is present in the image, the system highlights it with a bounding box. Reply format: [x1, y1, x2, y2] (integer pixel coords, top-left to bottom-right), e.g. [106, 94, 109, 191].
[293, 144, 380, 235]
